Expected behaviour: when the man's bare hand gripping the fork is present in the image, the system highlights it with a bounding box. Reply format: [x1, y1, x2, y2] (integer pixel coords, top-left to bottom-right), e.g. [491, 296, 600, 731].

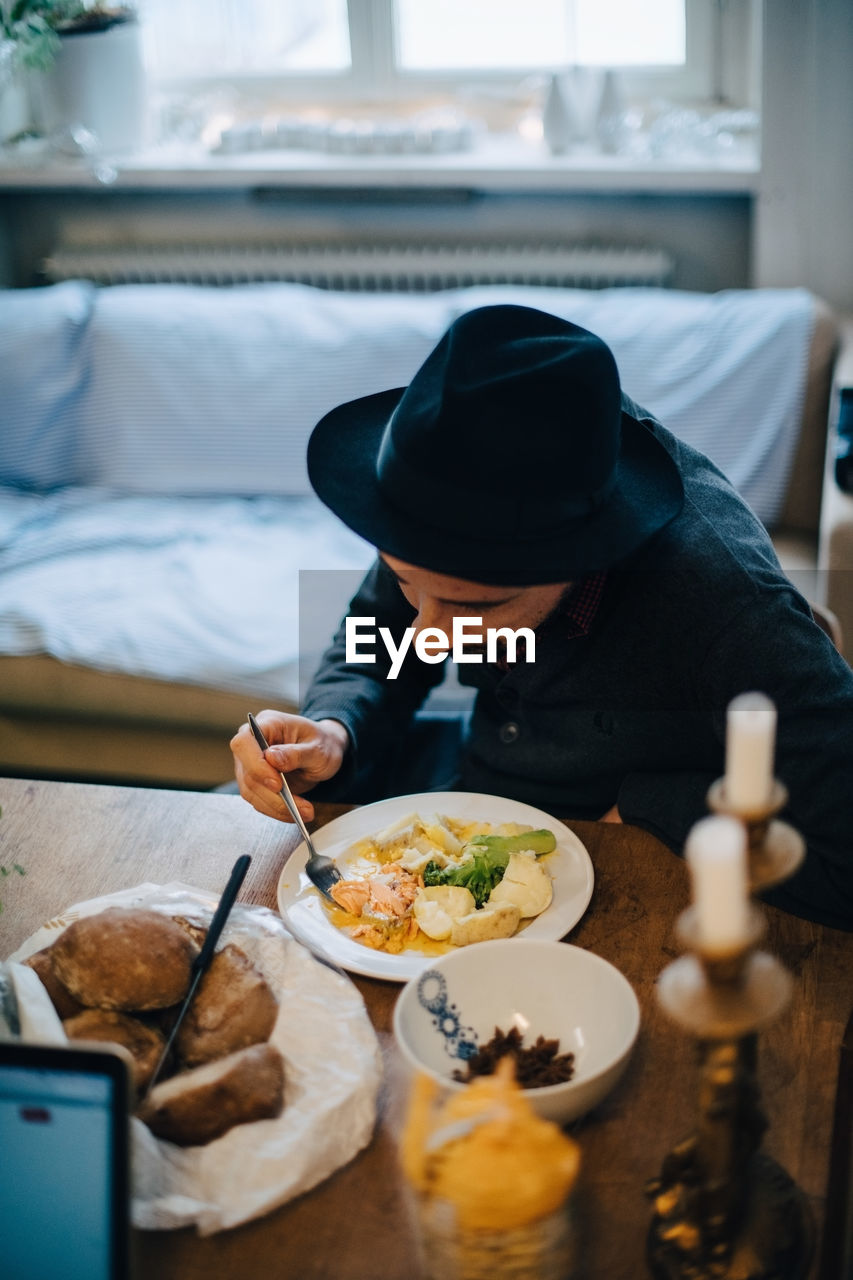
[231, 712, 350, 822]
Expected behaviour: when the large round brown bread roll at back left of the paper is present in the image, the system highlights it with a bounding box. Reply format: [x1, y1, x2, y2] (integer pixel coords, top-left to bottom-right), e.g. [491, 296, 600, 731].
[50, 906, 199, 1011]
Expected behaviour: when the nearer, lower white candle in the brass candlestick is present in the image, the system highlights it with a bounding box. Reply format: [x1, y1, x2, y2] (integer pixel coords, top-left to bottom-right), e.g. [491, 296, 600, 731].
[684, 814, 749, 951]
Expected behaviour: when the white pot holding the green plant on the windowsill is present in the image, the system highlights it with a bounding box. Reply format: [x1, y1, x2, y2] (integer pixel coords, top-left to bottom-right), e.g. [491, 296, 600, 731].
[31, 17, 147, 155]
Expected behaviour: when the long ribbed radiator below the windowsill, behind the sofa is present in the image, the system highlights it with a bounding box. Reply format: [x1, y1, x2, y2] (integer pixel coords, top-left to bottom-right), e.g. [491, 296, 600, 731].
[42, 243, 674, 292]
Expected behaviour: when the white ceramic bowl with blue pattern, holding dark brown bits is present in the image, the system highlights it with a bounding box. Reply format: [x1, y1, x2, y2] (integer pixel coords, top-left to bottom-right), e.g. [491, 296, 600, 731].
[393, 938, 639, 1124]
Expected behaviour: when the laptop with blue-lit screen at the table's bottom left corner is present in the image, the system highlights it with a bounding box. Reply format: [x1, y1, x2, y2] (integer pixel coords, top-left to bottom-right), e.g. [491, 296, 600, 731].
[0, 1041, 131, 1280]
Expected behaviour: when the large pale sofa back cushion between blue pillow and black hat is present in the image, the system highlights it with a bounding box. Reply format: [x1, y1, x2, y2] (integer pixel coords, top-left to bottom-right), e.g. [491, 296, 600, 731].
[77, 284, 455, 495]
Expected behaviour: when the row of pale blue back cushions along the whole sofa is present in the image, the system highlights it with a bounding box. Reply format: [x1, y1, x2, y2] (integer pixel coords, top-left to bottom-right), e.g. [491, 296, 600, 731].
[0, 282, 813, 527]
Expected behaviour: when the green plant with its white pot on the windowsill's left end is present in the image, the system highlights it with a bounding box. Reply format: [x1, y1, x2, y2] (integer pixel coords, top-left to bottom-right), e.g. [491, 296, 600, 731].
[0, 0, 145, 151]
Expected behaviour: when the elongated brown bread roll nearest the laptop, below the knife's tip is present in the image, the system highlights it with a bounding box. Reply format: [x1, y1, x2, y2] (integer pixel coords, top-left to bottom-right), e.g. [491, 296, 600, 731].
[137, 1044, 284, 1147]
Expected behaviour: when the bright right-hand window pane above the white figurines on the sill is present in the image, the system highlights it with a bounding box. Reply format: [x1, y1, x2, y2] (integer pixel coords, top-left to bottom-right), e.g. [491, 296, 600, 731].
[394, 0, 685, 70]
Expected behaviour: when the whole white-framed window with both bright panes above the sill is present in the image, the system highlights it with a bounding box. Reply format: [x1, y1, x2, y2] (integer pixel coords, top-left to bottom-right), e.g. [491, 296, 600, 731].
[138, 0, 737, 100]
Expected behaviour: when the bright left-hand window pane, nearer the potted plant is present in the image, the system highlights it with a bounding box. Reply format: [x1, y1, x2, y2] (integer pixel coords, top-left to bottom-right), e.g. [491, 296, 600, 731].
[140, 0, 350, 76]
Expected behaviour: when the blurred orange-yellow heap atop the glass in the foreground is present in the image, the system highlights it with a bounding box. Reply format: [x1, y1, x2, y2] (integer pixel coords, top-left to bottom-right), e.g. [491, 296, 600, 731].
[402, 1060, 580, 1233]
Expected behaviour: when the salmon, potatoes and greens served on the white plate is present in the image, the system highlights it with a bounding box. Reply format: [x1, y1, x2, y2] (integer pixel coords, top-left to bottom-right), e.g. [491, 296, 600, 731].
[322, 813, 557, 954]
